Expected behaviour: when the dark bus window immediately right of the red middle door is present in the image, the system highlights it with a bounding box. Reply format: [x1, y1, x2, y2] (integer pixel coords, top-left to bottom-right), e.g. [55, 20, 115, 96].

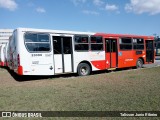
[119, 38, 132, 50]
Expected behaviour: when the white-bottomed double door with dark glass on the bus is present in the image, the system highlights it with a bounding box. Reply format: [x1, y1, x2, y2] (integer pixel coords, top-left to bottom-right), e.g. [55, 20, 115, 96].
[52, 36, 73, 74]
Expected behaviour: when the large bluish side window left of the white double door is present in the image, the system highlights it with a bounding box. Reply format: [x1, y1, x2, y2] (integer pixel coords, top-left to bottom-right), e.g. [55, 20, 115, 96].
[24, 33, 50, 52]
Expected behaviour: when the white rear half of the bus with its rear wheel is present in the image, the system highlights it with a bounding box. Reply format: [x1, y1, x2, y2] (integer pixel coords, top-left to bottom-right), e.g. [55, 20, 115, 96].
[8, 28, 105, 76]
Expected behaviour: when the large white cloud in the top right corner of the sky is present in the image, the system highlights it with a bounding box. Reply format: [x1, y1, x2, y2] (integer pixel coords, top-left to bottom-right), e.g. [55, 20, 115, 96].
[125, 0, 160, 15]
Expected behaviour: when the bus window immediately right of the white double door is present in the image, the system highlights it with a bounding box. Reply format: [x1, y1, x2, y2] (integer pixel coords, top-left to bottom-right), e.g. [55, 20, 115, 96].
[74, 36, 89, 51]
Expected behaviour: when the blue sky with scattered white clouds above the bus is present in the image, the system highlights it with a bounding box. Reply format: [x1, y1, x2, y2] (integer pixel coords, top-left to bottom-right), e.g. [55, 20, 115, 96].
[0, 0, 160, 35]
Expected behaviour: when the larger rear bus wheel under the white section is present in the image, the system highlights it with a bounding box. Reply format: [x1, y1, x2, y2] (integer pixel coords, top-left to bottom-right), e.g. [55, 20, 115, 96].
[77, 63, 91, 76]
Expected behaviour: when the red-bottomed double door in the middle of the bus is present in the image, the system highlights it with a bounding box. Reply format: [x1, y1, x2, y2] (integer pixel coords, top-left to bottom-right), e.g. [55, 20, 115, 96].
[105, 38, 118, 68]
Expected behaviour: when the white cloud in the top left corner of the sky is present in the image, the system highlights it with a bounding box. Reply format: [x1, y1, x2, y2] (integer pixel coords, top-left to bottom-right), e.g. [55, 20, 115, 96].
[0, 0, 18, 11]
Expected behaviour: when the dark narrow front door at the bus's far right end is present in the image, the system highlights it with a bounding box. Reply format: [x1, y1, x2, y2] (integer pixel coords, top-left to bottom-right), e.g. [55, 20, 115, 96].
[145, 40, 154, 63]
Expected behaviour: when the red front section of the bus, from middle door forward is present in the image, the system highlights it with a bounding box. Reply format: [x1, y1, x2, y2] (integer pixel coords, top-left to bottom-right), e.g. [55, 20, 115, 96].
[96, 33, 155, 69]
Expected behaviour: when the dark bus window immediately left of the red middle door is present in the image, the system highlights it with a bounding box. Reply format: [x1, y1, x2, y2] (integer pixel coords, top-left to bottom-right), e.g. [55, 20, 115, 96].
[91, 36, 103, 51]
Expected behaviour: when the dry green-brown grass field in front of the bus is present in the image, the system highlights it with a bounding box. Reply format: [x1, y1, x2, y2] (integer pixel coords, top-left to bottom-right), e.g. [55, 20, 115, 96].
[0, 67, 160, 119]
